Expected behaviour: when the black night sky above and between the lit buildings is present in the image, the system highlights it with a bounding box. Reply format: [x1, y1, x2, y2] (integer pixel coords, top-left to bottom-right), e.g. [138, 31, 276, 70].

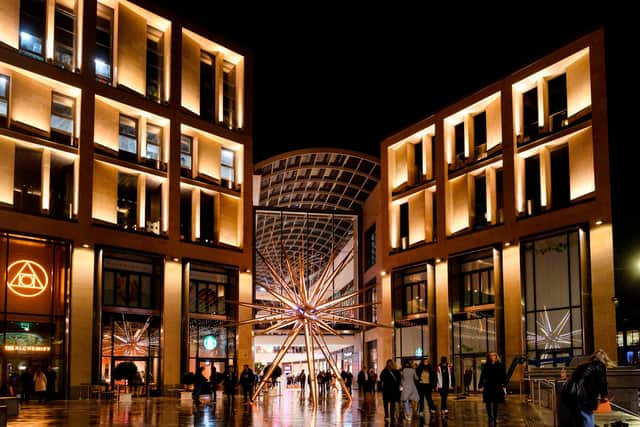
[156, 0, 640, 324]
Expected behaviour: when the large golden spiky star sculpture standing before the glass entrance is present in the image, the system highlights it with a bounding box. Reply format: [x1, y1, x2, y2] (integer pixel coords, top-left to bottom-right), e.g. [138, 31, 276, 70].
[236, 246, 382, 406]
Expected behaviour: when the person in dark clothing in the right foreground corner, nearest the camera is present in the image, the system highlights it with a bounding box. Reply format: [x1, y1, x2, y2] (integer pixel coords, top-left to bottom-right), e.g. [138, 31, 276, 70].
[562, 350, 614, 427]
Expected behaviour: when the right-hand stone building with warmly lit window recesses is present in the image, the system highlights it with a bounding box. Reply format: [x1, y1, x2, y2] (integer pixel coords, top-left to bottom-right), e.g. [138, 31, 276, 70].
[368, 32, 616, 387]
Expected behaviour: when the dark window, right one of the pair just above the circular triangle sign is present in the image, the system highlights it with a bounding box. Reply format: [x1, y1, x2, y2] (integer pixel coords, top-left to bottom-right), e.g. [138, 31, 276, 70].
[49, 154, 74, 219]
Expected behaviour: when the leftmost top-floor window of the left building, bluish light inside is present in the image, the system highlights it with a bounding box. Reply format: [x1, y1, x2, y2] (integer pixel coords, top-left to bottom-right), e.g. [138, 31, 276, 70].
[20, 0, 46, 61]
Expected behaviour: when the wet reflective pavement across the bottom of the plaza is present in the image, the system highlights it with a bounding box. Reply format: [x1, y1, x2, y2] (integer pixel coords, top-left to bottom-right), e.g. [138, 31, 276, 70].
[8, 389, 640, 427]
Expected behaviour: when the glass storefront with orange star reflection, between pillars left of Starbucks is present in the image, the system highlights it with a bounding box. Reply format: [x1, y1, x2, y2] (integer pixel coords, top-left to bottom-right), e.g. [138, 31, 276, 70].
[97, 249, 164, 395]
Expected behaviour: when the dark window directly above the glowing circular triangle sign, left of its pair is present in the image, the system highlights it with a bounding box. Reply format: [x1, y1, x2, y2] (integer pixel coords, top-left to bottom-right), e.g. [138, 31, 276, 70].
[13, 145, 42, 213]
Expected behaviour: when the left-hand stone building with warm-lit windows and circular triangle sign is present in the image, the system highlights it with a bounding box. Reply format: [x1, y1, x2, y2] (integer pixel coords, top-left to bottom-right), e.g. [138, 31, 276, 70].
[0, 0, 252, 397]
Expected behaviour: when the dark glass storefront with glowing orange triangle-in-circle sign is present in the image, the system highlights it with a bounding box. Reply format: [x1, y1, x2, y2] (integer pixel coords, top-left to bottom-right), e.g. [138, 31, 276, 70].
[0, 234, 69, 396]
